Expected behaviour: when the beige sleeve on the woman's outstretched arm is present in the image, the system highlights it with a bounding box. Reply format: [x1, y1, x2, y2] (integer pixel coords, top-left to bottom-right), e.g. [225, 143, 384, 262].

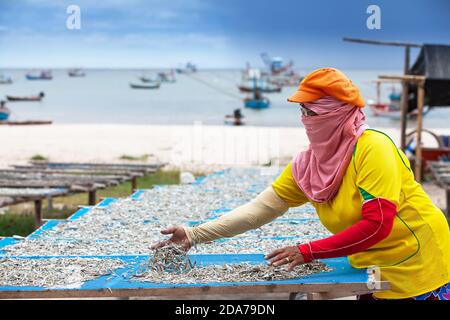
[184, 186, 289, 245]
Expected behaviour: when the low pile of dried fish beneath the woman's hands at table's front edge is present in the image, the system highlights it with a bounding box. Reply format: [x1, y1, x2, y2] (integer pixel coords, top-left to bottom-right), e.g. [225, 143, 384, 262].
[133, 262, 331, 284]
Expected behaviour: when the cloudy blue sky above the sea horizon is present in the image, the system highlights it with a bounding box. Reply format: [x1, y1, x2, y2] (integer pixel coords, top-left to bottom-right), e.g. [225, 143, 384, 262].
[0, 0, 450, 69]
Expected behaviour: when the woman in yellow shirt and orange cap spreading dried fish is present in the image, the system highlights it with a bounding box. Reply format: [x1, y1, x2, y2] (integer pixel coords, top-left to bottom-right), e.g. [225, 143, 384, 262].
[153, 68, 450, 300]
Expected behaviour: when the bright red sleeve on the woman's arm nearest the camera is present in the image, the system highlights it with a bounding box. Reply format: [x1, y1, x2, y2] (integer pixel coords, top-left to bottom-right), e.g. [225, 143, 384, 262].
[298, 198, 397, 262]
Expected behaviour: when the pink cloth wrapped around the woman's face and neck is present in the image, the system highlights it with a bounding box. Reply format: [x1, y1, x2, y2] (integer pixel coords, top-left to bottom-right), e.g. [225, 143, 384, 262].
[292, 97, 368, 202]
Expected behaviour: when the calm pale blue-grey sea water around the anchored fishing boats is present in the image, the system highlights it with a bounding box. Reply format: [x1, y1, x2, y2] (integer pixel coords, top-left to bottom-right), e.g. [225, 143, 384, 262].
[0, 69, 450, 128]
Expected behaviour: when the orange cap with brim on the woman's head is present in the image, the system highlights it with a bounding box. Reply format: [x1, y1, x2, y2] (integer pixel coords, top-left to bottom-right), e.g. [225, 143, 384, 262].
[288, 68, 365, 108]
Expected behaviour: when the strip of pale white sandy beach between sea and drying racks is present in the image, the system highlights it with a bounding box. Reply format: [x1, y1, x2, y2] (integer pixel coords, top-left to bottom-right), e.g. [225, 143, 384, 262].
[0, 123, 450, 171]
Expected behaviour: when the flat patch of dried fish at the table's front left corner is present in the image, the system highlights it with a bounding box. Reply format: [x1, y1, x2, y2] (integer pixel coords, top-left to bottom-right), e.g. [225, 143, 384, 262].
[0, 258, 124, 288]
